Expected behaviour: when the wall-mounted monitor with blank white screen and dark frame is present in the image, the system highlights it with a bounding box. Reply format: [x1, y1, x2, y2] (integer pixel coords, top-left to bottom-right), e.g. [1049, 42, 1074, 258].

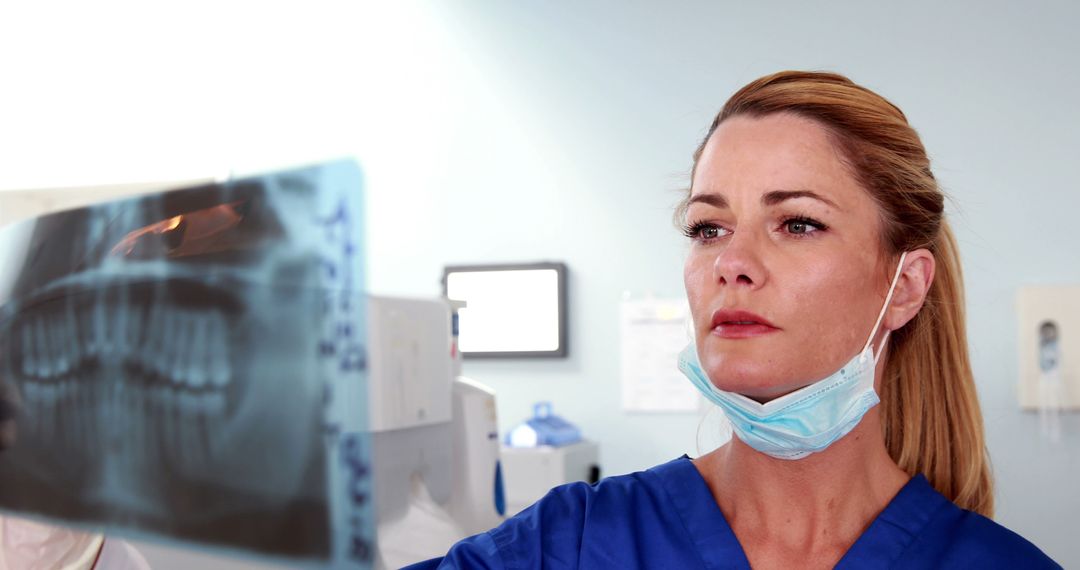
[443, 262, 567, 358]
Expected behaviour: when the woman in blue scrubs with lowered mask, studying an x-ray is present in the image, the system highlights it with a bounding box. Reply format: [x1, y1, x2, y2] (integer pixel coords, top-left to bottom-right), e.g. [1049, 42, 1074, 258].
[408, 71, 1057, 568]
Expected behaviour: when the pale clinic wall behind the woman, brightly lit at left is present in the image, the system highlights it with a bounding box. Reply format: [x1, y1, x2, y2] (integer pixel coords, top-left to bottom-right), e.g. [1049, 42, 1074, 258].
[0, 0, 1080, 567]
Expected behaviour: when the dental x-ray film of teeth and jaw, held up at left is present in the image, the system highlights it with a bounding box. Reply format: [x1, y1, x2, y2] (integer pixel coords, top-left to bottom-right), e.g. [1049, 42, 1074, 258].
[0, 161, 374, 568]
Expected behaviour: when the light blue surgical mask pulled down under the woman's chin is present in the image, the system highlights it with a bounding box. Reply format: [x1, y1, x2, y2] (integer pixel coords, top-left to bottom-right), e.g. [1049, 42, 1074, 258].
[678, 253, 907, 459]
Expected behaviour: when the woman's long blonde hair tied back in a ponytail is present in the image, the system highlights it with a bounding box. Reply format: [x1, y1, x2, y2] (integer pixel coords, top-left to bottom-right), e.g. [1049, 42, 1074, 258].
[675, 71, 994, 517]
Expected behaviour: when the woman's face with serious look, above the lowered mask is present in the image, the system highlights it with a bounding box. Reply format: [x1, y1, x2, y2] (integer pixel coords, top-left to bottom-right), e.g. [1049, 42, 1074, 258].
[684, 113, 894, 402]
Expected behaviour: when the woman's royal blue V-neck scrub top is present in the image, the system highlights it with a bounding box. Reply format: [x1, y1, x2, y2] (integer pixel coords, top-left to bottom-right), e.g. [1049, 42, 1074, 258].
[407, 456, 1061, 570]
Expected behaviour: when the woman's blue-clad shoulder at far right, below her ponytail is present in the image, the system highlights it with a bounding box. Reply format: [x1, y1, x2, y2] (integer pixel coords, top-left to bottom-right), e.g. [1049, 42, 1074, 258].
[915, 494, 1061, 568]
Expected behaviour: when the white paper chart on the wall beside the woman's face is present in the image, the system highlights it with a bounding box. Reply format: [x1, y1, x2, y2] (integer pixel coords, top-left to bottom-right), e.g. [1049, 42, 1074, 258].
[621, 299, 700, 411]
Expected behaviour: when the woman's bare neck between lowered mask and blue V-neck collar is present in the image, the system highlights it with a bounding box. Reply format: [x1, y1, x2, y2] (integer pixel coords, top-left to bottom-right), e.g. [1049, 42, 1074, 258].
[694, 407, 909, 564]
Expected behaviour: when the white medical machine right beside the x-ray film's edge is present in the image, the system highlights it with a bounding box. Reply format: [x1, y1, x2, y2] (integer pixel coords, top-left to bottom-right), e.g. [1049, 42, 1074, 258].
[368, 297, 503, 568]
